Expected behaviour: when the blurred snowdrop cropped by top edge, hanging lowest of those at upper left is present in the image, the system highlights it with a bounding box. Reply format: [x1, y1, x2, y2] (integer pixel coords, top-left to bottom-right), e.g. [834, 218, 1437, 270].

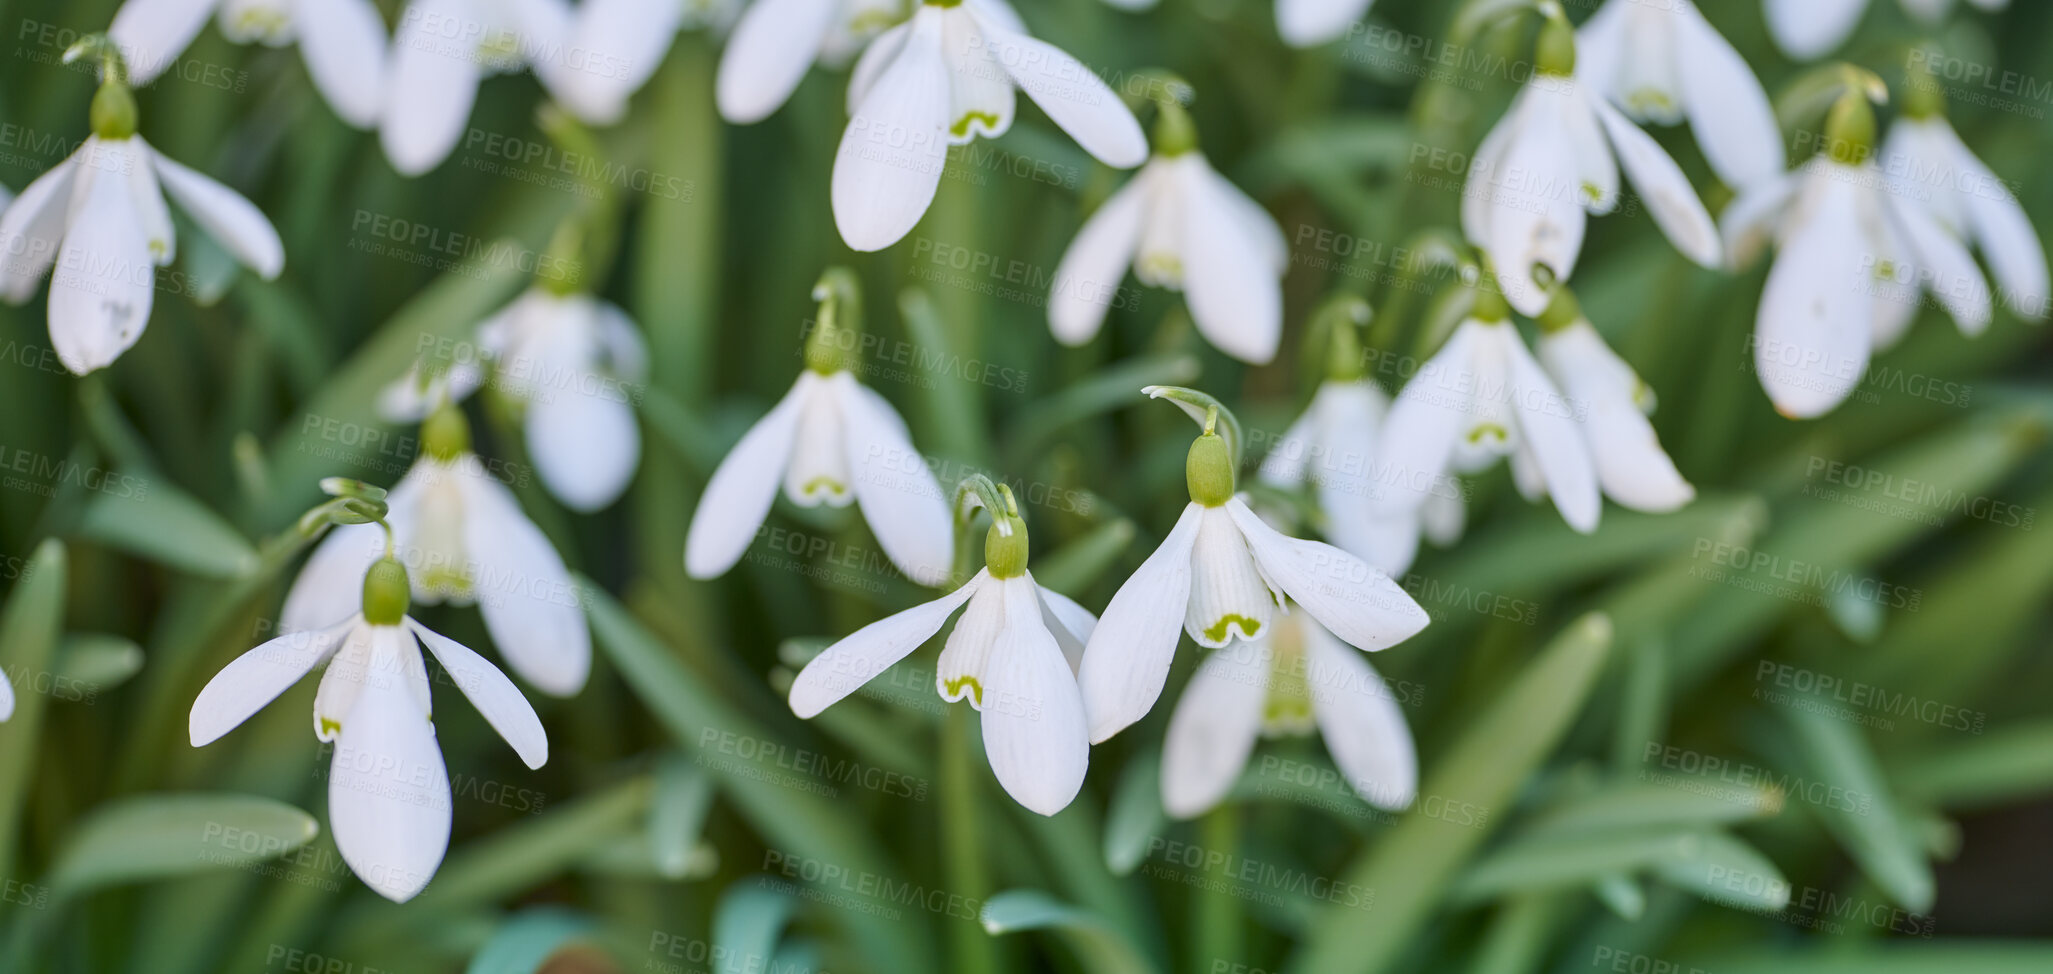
[378, 0, 566, 177]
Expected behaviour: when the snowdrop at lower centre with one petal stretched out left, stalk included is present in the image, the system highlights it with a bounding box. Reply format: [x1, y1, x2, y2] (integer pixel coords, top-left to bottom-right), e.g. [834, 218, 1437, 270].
[790, 477, 1096, 816]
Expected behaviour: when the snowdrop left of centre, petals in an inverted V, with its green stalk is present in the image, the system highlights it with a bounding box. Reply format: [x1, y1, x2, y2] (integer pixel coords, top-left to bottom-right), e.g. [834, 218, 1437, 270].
[684, 269, 955, 586]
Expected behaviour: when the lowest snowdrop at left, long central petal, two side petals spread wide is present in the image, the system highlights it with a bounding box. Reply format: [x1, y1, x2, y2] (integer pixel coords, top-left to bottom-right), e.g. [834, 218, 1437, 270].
[189, 550, 548, 902]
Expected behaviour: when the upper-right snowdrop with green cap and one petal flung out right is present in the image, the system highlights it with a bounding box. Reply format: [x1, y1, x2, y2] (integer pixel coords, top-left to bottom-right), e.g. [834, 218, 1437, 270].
[1462, 8, 1720, 316]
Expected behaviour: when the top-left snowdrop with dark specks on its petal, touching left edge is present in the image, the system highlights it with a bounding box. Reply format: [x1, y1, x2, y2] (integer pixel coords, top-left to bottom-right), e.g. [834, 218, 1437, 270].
[0, 37, 285, 376]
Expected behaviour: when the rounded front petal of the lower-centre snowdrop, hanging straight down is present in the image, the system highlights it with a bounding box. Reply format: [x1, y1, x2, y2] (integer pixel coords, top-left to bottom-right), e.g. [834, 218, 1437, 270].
[983, 575, 1090, 816]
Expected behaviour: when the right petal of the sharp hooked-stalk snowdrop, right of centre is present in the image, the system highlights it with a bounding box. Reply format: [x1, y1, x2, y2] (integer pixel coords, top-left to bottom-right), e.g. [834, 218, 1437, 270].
[1226, 497, 1429, 651]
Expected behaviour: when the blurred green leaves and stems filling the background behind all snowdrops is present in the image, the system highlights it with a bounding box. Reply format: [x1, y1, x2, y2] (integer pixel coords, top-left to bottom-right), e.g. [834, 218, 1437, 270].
[0, 0, 2053, 974]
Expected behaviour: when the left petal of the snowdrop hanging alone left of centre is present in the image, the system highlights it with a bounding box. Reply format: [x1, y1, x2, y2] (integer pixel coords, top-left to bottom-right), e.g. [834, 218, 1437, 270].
[684, 370, 819, 579]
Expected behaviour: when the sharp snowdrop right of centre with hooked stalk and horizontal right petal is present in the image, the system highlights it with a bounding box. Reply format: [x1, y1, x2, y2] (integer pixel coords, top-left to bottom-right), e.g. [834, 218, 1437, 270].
[1078, 386, 1427, 744]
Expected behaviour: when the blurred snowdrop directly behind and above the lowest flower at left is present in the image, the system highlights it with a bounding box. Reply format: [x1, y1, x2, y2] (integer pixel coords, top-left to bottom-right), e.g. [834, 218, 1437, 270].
[279, 405, 591, 697]
